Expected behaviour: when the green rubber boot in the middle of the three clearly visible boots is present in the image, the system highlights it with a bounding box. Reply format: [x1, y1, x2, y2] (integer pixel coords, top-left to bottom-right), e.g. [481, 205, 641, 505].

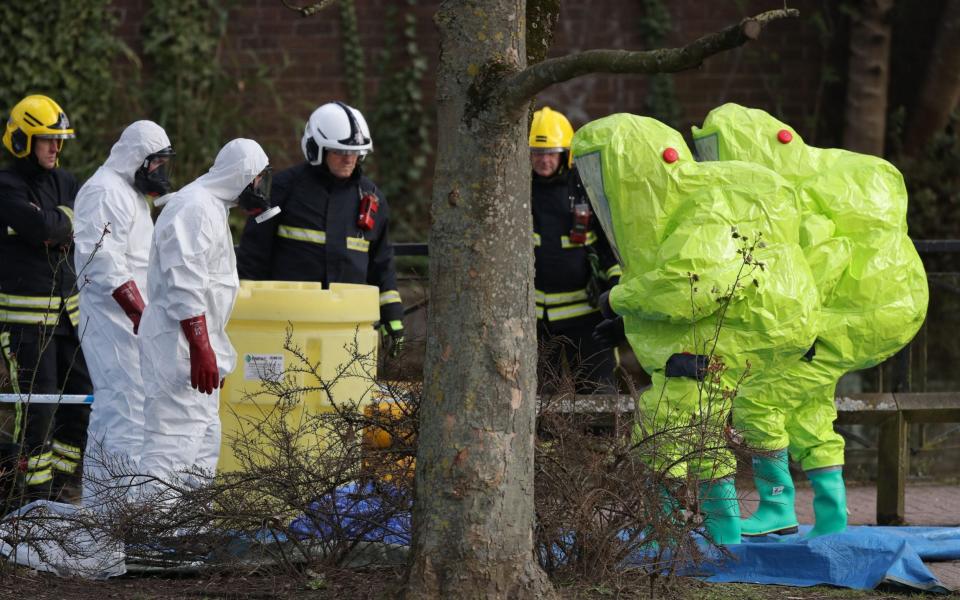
[740, 450, 797, 536]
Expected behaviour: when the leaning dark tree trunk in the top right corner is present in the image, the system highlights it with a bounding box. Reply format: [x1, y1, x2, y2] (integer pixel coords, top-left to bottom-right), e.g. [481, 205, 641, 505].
[903, 0, 960, 156]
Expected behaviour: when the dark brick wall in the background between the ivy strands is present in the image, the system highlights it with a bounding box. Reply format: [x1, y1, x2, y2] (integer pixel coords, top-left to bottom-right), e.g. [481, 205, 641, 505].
[115, 0, 824, 168]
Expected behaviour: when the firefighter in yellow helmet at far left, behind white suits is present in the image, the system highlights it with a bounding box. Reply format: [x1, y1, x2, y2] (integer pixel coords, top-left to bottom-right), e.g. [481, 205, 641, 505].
[0, 95, 92, 500]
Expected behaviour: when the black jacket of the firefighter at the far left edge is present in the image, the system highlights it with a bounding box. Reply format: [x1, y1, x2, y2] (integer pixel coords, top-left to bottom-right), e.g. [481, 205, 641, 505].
[0, 158, 79, 330]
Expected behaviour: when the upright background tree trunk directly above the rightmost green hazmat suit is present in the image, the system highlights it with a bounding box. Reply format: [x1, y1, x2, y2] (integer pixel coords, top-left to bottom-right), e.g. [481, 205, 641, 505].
[843, 0, 893, 156]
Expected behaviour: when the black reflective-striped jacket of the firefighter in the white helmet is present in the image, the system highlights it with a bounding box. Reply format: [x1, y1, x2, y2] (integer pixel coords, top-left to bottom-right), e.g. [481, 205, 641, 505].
[237, 163, 403, 322]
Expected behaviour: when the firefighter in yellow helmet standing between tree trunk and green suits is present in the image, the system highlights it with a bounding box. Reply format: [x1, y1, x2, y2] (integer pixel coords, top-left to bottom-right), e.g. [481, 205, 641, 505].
[529, 107, 623, 393]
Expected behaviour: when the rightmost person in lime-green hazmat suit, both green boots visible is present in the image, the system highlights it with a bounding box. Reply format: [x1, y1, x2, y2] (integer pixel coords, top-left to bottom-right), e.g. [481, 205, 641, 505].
[693, 104, 928, 537]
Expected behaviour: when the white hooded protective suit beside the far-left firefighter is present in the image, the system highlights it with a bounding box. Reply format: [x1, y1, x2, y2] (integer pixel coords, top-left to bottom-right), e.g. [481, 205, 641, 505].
[73, 121, 170, 506]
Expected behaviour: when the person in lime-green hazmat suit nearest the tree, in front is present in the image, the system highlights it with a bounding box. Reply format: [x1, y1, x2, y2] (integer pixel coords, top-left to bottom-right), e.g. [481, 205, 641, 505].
[572, 114, 818, 544]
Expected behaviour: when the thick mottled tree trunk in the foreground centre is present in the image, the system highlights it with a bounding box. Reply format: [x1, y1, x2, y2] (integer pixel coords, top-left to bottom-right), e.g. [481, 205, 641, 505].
[407, 0, 553, 599]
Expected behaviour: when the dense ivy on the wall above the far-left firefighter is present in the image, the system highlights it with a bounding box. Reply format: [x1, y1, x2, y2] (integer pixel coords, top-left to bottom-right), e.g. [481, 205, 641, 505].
[0, 0, 126, 179]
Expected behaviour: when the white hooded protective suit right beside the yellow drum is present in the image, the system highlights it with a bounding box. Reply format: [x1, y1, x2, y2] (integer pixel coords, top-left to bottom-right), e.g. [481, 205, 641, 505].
[131, 139, 268, 498]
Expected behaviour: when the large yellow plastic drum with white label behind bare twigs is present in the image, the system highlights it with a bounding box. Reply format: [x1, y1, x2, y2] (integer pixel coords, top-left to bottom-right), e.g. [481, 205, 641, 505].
[218, 281, 380, 471]
